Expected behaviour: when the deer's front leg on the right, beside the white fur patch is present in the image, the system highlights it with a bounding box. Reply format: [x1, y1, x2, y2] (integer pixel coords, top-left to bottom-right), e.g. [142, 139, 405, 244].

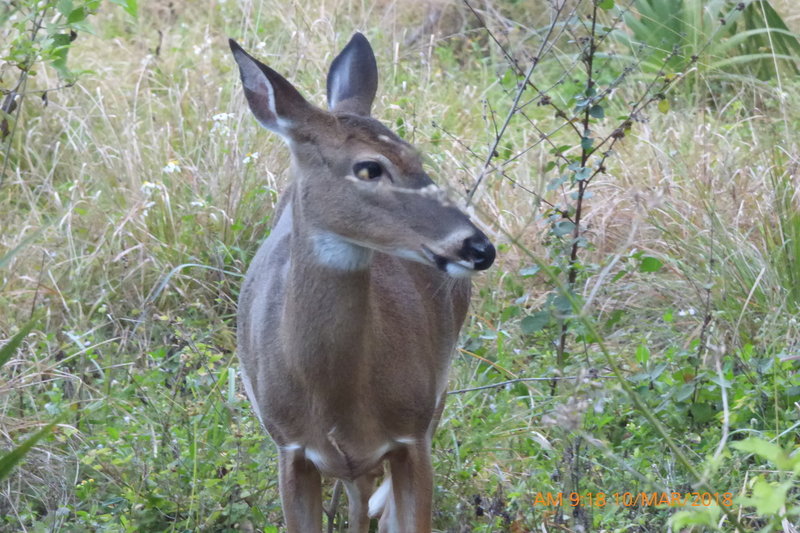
[380, 441, 433, 533]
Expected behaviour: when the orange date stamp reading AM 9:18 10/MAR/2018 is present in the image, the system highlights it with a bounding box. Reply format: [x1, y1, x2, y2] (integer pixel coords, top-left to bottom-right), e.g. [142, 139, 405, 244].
[533, 492, 733, 507]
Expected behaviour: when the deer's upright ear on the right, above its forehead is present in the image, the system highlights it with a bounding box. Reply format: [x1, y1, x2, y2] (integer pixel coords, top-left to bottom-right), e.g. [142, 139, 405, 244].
[328, 33, 378, 117]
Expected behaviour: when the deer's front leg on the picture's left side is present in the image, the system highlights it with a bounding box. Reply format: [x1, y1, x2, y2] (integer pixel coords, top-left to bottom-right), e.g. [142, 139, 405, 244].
[278, 449, 322, 533]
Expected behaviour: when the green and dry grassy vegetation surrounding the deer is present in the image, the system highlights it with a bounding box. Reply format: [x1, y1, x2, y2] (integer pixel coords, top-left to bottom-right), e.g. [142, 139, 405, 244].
[0, 0, 800, 532]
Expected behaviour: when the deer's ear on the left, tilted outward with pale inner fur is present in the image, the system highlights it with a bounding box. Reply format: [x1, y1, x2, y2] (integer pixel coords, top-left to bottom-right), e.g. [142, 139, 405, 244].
[228, 39, 313, 139]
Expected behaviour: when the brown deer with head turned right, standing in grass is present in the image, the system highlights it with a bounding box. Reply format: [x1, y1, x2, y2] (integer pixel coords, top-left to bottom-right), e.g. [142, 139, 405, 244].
[229, 33, 496, 533]
